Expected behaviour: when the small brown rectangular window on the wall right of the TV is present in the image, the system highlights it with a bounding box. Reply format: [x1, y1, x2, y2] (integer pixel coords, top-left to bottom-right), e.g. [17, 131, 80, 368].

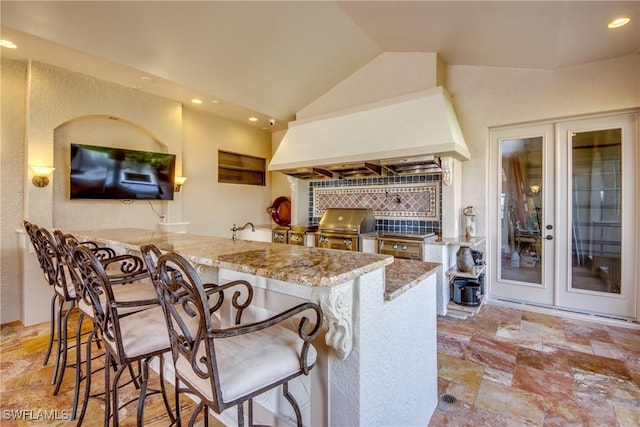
[218, 150, 267, 185]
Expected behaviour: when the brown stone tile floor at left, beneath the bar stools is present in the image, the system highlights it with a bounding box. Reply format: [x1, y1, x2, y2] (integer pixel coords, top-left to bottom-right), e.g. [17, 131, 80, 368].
[0, 312, 222, 427]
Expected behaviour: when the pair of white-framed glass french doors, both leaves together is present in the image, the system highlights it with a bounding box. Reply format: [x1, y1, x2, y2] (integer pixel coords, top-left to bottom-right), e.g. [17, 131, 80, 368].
[489, 114, 638, 319]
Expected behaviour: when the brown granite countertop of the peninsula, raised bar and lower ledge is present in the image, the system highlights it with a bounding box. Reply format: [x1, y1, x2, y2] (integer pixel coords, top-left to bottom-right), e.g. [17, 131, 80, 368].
[73, 228, 441, 301]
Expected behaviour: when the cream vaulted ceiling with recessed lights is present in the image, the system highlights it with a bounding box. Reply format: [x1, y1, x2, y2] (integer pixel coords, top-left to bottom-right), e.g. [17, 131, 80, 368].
[0, 0, 640, 129]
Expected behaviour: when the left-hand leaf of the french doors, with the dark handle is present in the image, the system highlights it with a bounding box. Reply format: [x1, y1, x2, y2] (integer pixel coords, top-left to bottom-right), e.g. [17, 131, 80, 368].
[489, 124, 555, 306]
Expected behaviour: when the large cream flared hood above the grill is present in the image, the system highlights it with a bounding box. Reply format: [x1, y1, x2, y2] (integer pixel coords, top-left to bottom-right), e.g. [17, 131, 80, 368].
[269, 86, 470, 179]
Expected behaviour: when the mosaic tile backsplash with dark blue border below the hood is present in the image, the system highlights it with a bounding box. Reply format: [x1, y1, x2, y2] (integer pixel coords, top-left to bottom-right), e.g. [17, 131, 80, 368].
[309, 174, 442, 234]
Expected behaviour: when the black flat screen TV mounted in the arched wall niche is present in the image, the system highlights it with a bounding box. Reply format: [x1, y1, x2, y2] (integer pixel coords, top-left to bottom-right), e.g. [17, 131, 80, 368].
[69, 144, 176, 200]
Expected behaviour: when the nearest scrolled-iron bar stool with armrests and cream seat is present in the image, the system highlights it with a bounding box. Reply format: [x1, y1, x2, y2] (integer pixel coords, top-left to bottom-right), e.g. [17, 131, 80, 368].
[149, 251, 322, 426]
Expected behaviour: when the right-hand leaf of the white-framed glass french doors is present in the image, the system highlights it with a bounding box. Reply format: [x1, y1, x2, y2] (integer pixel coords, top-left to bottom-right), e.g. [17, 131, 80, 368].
[556, 113, 639, 319]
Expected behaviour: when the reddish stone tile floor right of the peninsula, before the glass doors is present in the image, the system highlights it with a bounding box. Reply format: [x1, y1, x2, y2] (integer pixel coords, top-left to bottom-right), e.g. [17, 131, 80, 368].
[429, 305, 640, 427]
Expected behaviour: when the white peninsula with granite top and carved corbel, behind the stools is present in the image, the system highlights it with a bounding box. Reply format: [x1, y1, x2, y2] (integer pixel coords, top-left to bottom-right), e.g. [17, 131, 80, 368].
[74, 229, 440, 426]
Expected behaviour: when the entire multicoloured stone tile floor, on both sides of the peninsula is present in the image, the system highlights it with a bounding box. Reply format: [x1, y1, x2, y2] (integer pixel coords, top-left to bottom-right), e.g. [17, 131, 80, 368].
[0, 305, 640, 427]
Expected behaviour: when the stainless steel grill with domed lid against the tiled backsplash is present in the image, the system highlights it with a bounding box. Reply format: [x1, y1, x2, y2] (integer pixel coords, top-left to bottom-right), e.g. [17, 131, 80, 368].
[316, 208, 376, 251]
